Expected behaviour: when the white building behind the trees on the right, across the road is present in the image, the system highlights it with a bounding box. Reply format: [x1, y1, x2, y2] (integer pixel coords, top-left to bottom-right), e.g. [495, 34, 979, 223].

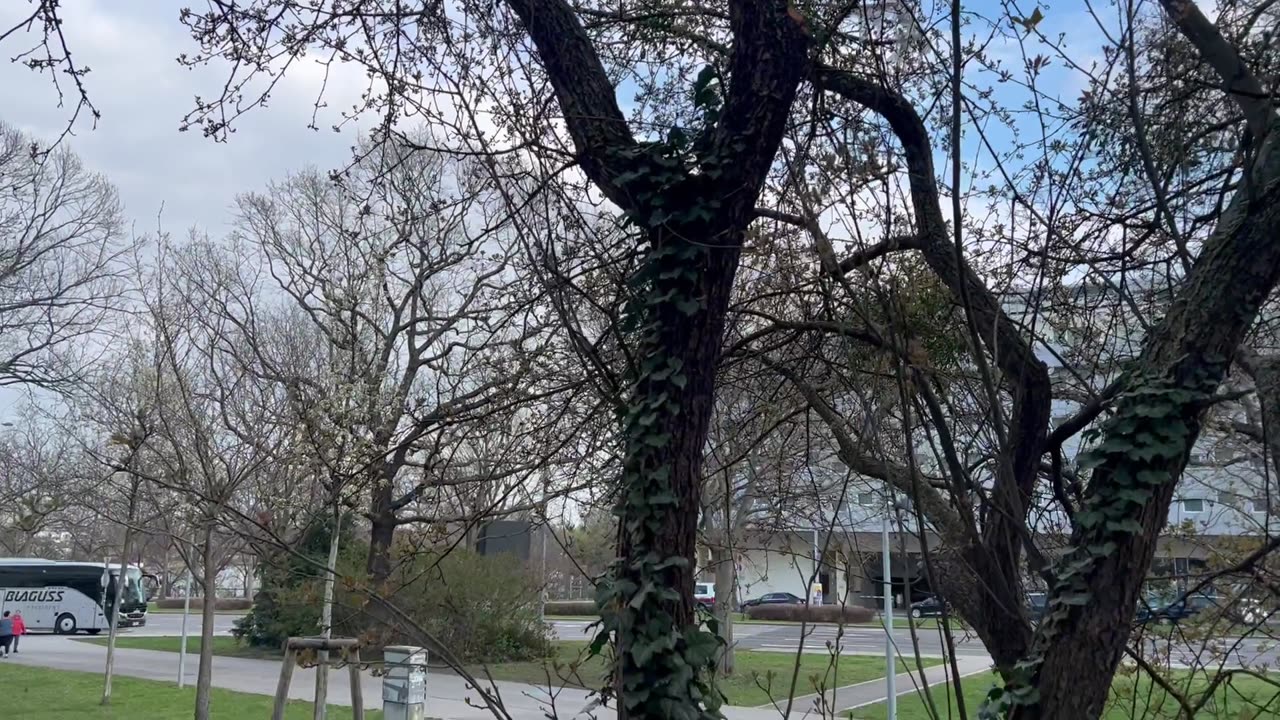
[703, 274, 1280, 606]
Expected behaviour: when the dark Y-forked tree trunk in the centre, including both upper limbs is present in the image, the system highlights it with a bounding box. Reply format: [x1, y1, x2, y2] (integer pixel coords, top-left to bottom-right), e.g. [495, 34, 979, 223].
[496, 0, 810, 720]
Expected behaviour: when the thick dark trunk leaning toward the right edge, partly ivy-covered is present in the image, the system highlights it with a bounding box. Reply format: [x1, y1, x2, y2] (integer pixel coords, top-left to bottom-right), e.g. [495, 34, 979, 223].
[1016, 112, 1280, 720]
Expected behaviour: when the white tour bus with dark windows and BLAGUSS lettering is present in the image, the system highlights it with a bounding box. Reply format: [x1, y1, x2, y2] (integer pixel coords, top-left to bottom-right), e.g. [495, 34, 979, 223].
[0, 557, 147, 635]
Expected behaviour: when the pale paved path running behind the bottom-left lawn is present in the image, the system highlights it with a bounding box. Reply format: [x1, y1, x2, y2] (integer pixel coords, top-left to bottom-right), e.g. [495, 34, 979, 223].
[5, 635, 778, 720]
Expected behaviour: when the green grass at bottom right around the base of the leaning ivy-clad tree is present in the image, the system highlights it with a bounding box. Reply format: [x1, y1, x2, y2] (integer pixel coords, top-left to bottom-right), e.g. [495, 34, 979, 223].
[849, 671, 1280, 720]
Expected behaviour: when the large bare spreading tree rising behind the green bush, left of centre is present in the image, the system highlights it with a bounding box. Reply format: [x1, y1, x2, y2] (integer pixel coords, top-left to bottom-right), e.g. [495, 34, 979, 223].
[195, 145, 540, 583]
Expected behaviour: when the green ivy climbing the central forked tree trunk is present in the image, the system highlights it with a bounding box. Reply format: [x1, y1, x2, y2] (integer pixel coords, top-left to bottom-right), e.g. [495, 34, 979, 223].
[591, 68, 726, 720]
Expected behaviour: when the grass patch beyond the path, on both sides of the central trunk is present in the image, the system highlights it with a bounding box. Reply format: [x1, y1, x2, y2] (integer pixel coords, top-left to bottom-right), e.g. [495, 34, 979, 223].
[472, 642, 940, 706]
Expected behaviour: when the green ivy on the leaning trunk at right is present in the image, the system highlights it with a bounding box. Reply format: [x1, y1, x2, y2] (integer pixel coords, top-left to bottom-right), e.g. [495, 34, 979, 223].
[979, 363, 1220, 720]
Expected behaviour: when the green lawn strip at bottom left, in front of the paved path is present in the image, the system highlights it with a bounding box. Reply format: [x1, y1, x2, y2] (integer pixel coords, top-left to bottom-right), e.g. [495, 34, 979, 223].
[0, 662, 383, 720]
